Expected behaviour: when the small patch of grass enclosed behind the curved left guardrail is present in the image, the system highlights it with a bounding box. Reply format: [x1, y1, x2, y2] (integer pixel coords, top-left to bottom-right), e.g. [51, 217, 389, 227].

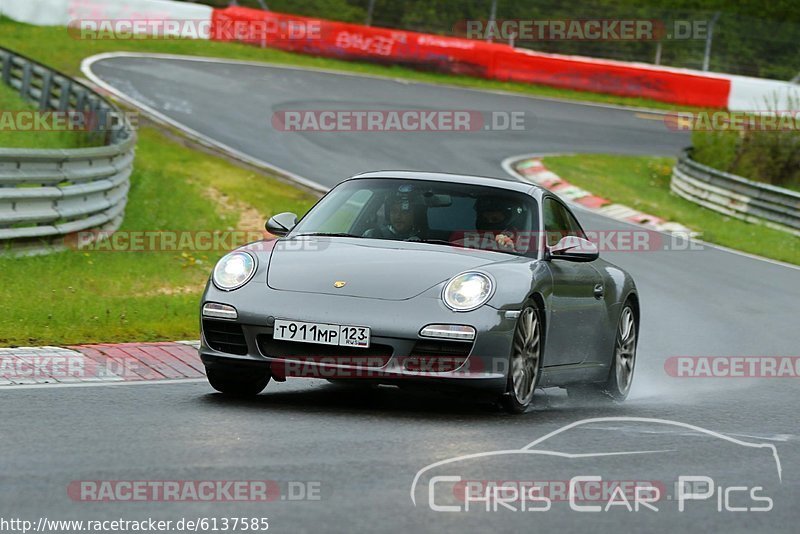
[0, 83, 103, 148]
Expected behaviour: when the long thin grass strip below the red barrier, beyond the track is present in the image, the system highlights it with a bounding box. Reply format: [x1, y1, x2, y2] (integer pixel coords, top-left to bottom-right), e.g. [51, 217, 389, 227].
[0, 18, 697, 113]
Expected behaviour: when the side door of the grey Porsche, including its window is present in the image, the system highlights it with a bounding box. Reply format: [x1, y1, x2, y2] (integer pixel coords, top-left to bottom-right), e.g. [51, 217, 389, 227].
[542, 196, 605, 366]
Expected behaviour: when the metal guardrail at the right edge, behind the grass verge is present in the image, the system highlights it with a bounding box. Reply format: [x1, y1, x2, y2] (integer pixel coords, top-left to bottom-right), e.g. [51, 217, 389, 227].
[670, 148, 800, 235]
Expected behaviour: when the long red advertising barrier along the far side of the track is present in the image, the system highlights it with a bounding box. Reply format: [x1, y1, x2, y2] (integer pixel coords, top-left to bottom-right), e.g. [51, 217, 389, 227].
[211, 7, 730, 108]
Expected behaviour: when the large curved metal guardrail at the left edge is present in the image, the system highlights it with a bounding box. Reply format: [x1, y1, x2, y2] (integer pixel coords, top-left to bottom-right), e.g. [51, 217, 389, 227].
[0, 47, 136, 254]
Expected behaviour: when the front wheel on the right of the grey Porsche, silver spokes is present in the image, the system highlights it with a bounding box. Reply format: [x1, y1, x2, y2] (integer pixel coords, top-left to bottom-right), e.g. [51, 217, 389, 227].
[501, 306, 543, 414]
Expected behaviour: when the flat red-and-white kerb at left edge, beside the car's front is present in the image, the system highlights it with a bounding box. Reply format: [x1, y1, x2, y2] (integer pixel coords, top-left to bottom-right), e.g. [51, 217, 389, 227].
[0, 341, 205, 391]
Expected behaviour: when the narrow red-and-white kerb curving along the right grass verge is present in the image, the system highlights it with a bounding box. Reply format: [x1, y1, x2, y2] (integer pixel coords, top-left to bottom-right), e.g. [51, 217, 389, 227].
[510, 156, 698, 237]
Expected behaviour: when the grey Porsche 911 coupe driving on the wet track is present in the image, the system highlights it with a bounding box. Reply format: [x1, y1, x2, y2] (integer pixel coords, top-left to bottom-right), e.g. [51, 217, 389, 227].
[200, 171, 639, 413]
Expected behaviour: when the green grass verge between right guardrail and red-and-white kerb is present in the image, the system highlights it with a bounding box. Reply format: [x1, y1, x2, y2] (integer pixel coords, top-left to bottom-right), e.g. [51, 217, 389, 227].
[545, 155, 800, 265]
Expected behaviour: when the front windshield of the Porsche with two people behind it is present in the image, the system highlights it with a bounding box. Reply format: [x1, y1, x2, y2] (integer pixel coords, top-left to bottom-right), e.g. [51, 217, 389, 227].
[289, 178, 538, 256]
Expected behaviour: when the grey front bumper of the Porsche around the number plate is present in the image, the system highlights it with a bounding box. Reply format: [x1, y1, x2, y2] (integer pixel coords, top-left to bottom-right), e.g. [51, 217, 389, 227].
[200, 280, 516, 392]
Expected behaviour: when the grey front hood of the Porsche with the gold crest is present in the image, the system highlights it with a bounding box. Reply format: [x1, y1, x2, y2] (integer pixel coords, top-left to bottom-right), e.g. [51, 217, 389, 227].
[267, 237, 511, 300]
